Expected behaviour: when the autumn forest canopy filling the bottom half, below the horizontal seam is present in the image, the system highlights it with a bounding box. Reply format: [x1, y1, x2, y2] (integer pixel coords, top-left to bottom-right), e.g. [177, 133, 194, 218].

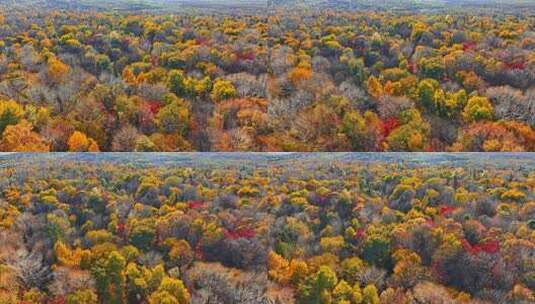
[0, 154, 535, 304]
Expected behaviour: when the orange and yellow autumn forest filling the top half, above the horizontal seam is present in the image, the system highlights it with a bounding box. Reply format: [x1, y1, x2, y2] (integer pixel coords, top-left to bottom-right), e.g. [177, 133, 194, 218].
[0, 0, 535, 152]
